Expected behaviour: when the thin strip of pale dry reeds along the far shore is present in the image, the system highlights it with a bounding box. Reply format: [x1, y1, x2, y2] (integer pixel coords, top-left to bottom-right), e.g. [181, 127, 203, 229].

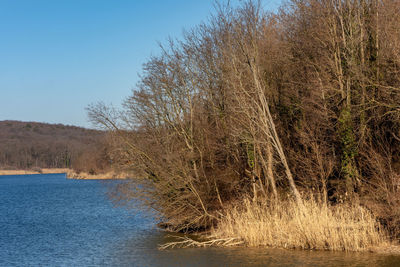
[0, 168, 129, 180]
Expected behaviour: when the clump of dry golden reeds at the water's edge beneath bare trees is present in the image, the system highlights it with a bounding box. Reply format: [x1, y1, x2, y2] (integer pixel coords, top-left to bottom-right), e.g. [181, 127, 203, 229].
[214, 199, 384, 251]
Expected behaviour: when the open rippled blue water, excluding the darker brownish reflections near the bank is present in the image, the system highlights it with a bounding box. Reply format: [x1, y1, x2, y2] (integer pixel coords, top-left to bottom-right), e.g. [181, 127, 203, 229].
[0, 174, 151, 266]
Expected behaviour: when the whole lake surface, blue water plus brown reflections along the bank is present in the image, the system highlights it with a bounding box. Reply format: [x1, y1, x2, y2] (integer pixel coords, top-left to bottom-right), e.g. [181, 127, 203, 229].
[0, 174, 400, 266]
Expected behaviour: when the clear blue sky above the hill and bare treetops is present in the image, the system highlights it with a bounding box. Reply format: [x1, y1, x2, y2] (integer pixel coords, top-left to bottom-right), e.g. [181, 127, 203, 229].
[0, 0, 280, 127]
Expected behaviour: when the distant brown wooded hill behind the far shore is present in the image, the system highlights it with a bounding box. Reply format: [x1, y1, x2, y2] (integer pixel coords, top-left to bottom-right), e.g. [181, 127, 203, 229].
[0, 120, 107, 172]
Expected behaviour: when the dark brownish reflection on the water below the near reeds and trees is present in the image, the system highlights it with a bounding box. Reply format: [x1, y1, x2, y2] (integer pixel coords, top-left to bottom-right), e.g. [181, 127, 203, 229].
[113, 231, 400, 267]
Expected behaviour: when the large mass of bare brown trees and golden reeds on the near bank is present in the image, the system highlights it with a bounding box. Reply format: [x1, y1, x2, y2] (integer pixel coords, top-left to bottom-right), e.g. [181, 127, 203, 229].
[88, 0, 400, 250]
